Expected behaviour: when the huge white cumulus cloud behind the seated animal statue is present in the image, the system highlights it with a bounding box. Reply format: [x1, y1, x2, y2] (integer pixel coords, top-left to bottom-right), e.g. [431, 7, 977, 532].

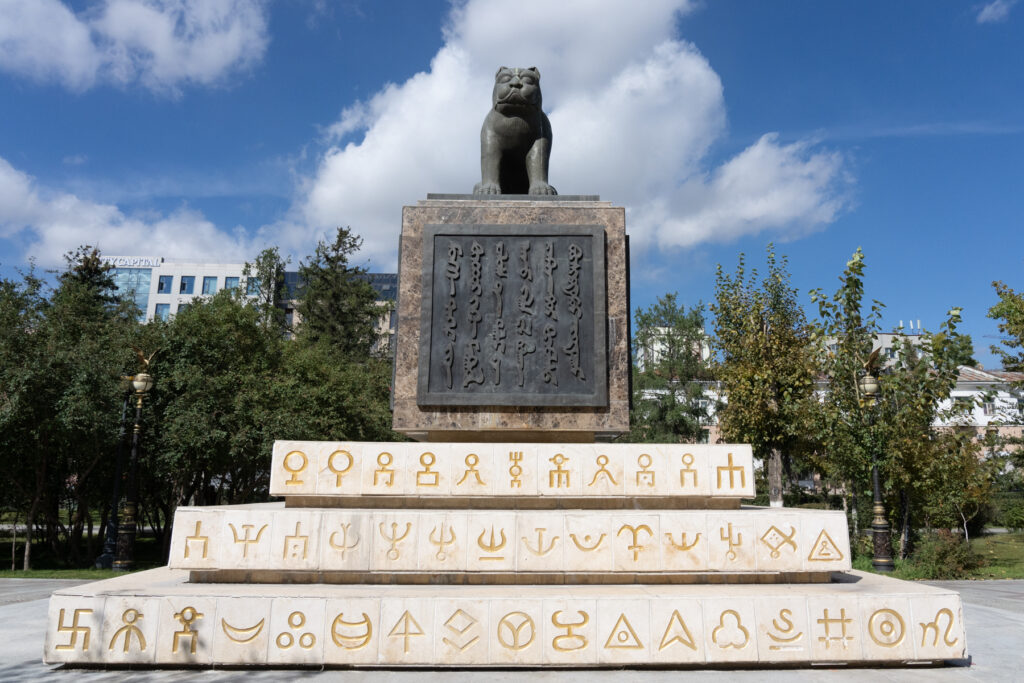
[286, 0, 849, 268]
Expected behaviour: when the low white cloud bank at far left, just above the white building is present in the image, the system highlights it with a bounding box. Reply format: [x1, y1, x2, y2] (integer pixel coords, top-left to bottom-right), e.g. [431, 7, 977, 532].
[0, 158, 259, 266]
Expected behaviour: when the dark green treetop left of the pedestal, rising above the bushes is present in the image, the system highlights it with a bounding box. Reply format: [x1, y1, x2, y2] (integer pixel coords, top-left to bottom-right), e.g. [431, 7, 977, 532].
[297, 227, 387, 356]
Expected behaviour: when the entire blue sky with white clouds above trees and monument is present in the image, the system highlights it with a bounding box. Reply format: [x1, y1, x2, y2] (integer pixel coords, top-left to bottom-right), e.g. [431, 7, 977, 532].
[0, 0, 1024, 367]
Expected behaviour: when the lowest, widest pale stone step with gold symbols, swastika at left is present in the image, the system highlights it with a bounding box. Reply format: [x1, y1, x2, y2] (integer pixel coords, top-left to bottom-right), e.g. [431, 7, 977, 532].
[43, 568, 967, 667]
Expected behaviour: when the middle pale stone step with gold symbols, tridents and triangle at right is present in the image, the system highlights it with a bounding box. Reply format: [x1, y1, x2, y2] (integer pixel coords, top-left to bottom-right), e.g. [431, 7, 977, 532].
[170, 504, 850, 574]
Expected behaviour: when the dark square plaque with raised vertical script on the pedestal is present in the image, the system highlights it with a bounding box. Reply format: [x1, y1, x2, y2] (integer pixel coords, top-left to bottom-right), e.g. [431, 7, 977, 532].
[417, 224, 608, 407]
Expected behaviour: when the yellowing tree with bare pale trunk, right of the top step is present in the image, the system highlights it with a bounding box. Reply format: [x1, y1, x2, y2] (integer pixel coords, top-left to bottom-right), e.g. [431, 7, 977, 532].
[711, 244, 816, 506]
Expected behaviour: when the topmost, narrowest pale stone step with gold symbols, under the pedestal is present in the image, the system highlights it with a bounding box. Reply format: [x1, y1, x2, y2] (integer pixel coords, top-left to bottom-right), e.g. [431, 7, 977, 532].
[270, 441, 754, 499]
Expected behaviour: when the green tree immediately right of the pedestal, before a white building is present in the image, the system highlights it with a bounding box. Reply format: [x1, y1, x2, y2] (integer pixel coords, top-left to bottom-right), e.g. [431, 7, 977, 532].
[629, 293, 712, 443]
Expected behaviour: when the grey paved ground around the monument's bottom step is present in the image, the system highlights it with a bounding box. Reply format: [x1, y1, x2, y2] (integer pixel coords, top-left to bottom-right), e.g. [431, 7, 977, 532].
[0, 579, 1024, 683]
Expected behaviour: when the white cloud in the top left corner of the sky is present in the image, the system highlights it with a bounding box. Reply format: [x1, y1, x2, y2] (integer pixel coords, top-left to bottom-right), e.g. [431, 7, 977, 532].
[0, 0, 267, 94]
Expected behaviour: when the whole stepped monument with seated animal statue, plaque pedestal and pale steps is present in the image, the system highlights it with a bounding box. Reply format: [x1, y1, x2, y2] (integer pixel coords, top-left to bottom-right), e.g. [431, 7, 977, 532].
[44, 68, 967, 668]
